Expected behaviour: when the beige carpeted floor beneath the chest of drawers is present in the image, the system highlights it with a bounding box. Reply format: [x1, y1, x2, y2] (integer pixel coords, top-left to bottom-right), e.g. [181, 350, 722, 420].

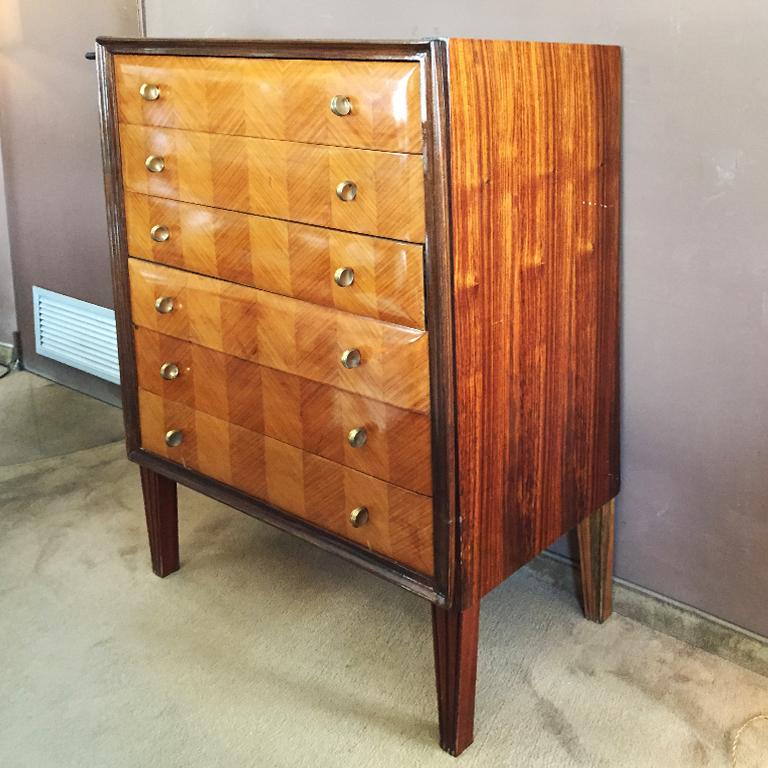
[0, 373, 768, 768]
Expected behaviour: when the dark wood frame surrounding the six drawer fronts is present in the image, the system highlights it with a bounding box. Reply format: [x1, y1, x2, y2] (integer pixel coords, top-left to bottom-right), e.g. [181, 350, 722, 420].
[96, 38, 460, 607]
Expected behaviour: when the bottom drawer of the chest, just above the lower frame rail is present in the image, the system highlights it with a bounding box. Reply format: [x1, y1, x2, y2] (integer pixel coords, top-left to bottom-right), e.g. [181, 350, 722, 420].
[139, 390, 433, 575]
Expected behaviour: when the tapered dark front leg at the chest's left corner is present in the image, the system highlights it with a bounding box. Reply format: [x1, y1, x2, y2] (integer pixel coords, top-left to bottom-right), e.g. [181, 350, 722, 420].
[139, 467, 179, 576]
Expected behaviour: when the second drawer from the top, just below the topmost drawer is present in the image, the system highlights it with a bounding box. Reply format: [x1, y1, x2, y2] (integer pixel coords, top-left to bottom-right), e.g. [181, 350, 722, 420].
[120, 124, 424, 243]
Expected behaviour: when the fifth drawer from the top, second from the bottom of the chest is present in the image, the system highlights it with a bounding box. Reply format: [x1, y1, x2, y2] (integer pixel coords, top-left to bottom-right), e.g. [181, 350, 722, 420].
[135, 327, 432, 495]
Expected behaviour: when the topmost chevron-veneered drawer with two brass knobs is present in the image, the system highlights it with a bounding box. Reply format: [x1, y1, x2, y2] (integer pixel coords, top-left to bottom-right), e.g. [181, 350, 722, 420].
[115, 56, 423, 153]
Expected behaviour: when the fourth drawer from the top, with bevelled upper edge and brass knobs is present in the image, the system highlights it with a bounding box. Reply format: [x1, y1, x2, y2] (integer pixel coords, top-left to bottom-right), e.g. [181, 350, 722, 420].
[128, 259, 429, 413]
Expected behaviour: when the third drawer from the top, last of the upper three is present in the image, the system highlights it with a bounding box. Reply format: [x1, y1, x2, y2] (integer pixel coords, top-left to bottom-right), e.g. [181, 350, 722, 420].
[125, 192, 424, 328]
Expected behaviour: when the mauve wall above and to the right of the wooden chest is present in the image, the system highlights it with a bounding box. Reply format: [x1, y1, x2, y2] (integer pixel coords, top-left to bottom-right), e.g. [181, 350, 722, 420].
[146, 0, 768, 635]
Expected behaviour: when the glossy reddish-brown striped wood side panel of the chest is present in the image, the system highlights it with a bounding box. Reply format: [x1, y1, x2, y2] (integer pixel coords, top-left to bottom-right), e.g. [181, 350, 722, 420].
[449, 40, 620, 600]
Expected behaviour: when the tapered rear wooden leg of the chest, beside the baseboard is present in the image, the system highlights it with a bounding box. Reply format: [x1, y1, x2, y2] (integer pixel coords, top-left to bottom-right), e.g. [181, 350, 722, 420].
[577, 499, 614, 624]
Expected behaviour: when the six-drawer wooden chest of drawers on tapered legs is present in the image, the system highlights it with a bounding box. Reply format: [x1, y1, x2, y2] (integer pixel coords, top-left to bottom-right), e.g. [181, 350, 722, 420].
[97, 38, 620, 754]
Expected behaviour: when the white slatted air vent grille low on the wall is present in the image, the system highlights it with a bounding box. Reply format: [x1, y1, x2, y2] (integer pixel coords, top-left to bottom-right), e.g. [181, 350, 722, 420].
[32, 285, 120, 384]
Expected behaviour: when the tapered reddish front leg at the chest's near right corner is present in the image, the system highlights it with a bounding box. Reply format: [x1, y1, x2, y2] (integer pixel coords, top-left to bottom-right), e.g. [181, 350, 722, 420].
[432, 601, 480, 755]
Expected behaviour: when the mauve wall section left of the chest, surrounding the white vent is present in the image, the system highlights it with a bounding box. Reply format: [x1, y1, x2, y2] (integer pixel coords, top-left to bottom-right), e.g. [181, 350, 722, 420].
[0, 0, 138, 402]
